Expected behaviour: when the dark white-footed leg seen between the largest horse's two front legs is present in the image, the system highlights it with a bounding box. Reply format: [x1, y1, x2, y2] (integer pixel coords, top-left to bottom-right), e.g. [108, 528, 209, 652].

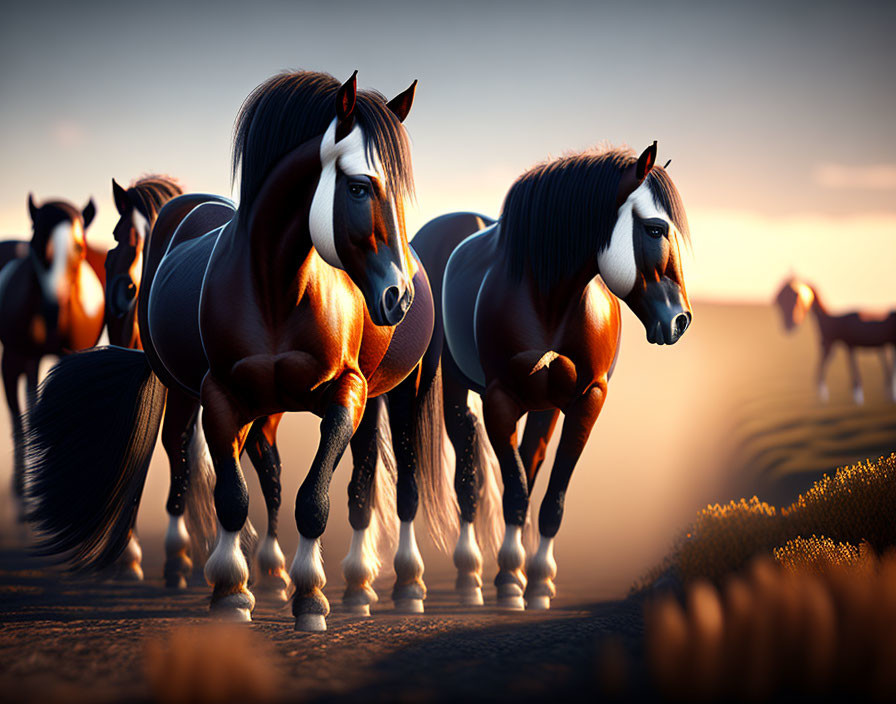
[246, 414, 289, 601]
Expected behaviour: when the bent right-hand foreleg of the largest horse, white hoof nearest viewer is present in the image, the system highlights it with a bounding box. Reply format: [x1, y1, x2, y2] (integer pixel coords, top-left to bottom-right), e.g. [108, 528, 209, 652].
[289, 371, 367, 631]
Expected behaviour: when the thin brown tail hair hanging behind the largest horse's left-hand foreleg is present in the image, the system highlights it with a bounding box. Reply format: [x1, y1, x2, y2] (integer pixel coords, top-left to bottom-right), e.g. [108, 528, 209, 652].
[184, 409, 258, 566]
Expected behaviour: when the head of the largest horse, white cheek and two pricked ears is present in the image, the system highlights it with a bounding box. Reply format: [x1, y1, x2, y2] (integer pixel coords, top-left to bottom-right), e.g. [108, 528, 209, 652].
[309, 71, 417, 325]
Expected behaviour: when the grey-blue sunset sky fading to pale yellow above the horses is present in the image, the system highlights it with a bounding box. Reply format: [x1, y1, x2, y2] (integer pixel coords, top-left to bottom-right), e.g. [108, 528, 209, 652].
[0, 0, 896, 309]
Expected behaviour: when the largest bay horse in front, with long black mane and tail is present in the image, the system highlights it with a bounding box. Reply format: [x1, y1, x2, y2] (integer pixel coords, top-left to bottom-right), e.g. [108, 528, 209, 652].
[28, 72, 432, 630]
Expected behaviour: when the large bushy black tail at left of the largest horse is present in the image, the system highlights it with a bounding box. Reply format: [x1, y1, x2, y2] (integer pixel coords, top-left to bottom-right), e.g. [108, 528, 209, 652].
[25, 347, 166, 570]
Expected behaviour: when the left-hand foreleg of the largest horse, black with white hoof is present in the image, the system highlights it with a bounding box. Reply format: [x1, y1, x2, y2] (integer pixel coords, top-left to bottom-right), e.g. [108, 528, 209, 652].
[201, 374, 255, 621]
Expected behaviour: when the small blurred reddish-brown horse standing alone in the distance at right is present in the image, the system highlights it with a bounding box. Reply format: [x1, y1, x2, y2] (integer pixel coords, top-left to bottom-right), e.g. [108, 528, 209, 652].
[775, 278, 896, 404]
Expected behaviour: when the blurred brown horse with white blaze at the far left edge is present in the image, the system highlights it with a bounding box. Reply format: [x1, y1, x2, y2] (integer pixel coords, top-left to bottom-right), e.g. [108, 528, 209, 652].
[0, 195, 103, 516]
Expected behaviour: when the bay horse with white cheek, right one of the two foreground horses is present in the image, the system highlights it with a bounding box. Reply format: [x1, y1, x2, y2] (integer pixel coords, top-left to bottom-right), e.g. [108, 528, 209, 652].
[376, 143, 691, 609]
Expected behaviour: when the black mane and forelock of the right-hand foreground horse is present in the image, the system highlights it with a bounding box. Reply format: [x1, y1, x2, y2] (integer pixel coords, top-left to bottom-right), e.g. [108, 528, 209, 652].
[500, 148, 689, 291]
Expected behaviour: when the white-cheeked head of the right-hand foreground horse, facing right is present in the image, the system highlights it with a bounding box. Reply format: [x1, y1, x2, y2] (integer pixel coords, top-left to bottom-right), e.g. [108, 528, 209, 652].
[598, 142, 692, 345]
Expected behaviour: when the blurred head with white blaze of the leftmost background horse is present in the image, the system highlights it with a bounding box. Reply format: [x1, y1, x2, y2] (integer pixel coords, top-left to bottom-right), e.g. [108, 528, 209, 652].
[28, 194, 96, 332]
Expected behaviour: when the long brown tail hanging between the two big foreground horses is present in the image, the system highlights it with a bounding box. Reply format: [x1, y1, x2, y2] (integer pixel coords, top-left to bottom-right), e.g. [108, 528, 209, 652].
[414, 364, 460, 552]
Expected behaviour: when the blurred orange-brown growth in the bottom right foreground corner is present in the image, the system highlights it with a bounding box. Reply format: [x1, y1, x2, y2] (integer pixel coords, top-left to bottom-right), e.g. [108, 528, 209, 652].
[645, 556, 896, 701]
